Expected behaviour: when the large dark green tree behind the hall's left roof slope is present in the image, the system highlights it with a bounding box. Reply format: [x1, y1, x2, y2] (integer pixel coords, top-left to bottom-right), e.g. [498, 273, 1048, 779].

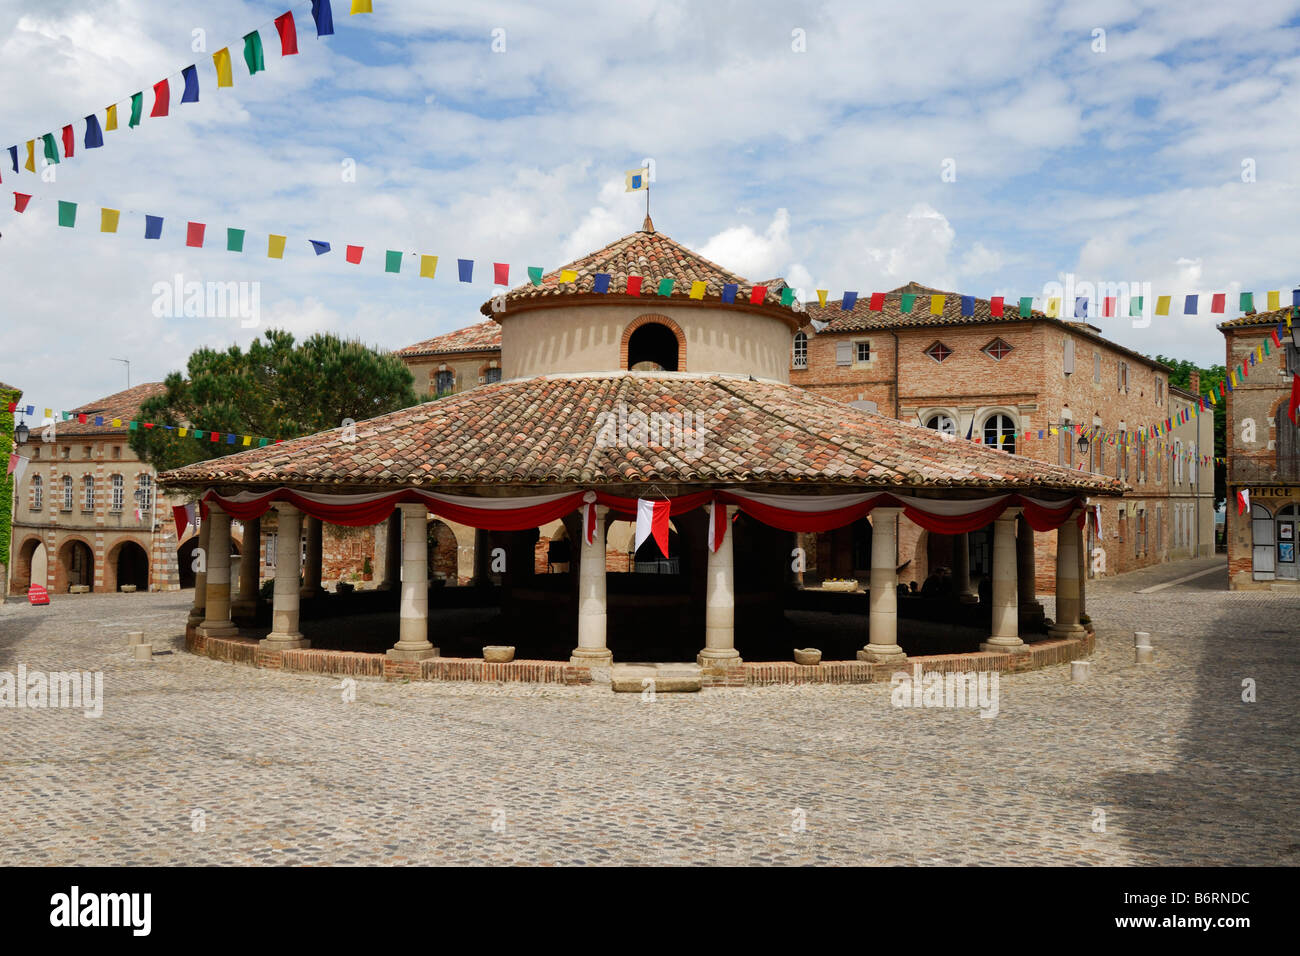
[130, 329, 420, 471]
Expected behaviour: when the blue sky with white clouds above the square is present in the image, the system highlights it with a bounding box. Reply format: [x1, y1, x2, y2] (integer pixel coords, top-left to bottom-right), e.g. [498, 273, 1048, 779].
[0, 0, 1300, 407]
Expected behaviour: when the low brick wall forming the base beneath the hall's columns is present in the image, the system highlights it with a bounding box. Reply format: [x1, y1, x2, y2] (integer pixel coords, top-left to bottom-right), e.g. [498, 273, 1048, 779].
[185, 633, 1096, 687]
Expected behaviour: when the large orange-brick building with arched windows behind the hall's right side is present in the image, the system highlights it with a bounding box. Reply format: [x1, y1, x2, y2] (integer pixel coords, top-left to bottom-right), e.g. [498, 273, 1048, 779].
[790, 282, 1214, 592]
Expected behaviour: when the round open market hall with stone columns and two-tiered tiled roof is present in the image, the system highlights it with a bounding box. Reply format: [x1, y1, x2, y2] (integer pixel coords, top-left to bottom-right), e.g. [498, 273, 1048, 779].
[160, 220, 1130, 676]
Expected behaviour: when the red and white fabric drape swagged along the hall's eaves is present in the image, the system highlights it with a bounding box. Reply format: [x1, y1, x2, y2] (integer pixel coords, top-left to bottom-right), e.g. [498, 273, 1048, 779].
[202, 488, 1086, 542]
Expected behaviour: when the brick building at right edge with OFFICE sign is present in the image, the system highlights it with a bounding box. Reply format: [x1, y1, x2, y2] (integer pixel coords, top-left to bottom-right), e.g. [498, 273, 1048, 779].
[1219, 308, 1300, 591]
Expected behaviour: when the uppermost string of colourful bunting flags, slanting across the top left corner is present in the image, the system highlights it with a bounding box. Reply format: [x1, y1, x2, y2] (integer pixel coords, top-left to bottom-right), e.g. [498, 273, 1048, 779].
[0, 0, 373, 182]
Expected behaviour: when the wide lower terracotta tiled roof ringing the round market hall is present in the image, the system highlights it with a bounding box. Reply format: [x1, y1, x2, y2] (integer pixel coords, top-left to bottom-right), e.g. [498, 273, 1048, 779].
[160, 372, 1123, 494]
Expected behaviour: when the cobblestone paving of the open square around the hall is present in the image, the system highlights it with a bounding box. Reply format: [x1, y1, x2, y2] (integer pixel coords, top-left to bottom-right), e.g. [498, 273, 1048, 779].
[0, 562, 1300, 865]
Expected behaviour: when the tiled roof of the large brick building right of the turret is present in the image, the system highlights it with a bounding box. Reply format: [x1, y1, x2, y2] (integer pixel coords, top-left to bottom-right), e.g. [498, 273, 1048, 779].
[805, 282, 1169, 371]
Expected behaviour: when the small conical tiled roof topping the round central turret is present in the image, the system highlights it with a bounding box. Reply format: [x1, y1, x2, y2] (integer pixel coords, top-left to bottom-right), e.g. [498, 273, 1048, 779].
[480, 230, 797, 321]
